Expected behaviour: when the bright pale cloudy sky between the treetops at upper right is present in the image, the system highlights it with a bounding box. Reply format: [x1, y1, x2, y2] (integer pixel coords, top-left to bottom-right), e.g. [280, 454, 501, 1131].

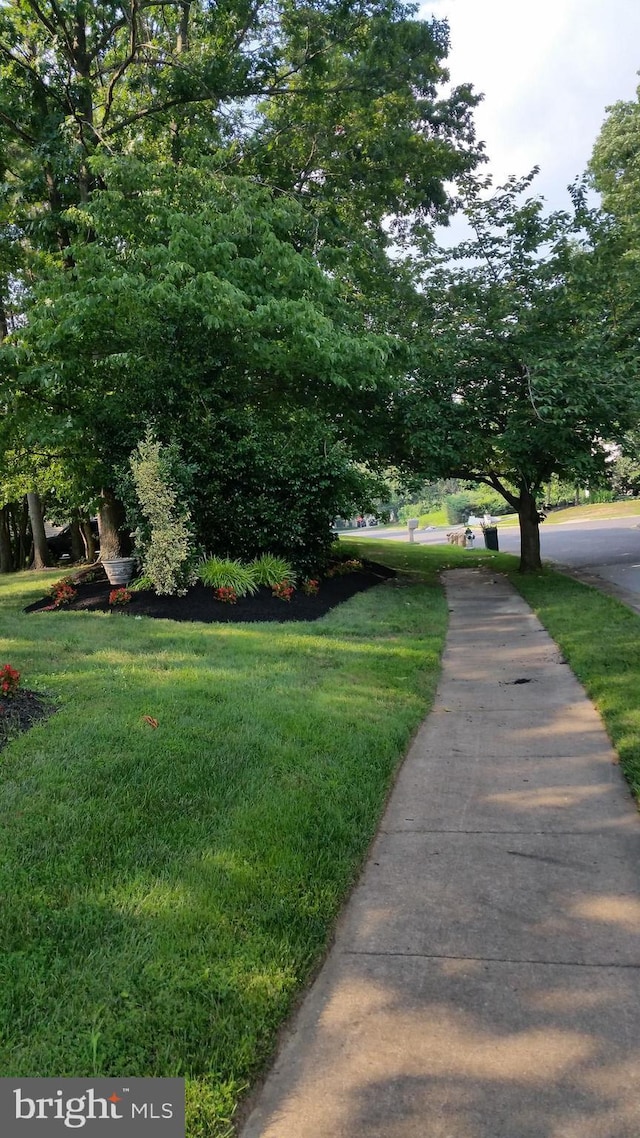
[420, 0, 640, 215]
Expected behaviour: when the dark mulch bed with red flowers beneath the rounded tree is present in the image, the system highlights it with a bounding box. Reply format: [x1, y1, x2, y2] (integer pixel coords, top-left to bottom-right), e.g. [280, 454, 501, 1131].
[24, 562, 395, 624]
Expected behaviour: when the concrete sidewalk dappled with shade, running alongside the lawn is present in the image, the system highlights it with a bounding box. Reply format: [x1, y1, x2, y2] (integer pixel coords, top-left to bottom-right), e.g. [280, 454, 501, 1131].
[241, 569, 640, 1138]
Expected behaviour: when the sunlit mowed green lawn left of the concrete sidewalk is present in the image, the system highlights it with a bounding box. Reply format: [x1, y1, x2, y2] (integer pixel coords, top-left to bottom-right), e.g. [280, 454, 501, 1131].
[0, 564, 448, 1138]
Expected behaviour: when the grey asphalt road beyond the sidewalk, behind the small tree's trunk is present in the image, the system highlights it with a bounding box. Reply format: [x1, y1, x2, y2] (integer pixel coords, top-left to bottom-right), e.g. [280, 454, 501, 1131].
[350, 517, 640, 608]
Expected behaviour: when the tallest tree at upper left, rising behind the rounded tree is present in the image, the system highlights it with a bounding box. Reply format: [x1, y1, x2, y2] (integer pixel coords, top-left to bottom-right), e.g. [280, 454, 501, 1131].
[0, 0, 477, 559]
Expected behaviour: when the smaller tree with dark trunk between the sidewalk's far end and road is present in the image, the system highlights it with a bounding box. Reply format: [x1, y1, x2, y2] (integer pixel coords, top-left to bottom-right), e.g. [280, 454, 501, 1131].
[399, 172, 639, 571]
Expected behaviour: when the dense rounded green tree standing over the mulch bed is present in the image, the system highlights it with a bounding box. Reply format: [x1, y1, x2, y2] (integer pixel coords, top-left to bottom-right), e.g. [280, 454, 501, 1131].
[2, 159, 401, 563]
